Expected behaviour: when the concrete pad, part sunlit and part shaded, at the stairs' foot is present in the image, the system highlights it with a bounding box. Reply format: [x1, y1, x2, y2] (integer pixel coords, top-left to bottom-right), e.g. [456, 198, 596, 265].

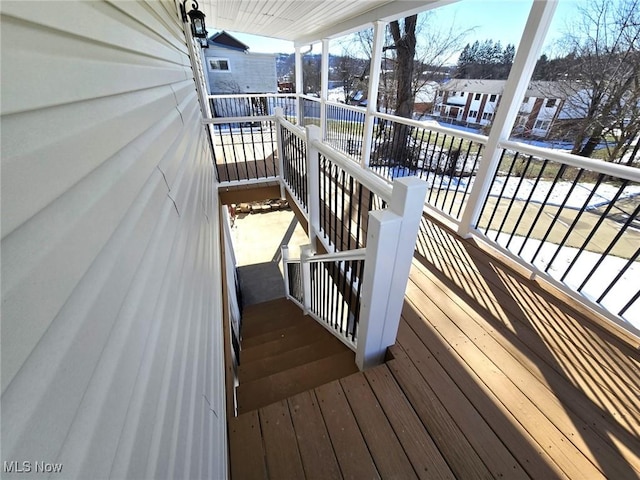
[232, 210, 309, 306]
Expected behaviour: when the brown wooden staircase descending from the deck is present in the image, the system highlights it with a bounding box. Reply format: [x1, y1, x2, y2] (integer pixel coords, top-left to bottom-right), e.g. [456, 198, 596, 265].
[236, 298, 358, 415]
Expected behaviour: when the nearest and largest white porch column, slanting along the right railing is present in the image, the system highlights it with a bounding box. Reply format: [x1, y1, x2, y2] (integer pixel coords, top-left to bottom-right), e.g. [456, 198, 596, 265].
[458, 0, 557, 237]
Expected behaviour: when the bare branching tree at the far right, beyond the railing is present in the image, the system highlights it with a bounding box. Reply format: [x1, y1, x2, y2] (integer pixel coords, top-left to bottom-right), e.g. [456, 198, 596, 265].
[561, 0, 640, 161]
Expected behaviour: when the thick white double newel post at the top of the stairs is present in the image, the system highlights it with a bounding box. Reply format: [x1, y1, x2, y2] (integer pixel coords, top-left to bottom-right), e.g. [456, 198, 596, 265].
[356, 177, 427, 370]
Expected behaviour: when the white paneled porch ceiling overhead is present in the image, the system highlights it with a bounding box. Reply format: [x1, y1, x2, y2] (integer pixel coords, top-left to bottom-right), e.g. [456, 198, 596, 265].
[200, 0, 458, 46]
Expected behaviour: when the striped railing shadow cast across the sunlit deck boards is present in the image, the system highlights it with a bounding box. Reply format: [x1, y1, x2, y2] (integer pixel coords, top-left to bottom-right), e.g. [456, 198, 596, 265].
[415, 217, 640, 478]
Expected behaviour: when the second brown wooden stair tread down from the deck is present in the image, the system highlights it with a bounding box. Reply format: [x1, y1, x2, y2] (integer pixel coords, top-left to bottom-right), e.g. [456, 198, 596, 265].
[238, 334, 348, 383]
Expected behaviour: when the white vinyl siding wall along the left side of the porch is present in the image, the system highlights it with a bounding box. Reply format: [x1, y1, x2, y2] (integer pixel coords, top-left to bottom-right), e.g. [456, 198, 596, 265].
[0, 1, 227, 478]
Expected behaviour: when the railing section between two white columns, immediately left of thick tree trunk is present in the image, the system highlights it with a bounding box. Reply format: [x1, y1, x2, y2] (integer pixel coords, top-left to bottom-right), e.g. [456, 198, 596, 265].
[325, 104, 365, 161]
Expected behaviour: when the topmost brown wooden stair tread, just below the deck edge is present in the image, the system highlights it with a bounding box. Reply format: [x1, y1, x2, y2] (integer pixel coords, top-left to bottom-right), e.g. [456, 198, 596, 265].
[236, 350, 358, 414]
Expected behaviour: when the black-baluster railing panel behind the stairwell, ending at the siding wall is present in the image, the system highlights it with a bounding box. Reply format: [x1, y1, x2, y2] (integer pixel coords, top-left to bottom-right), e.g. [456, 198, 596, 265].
[210, 120, 278, 182]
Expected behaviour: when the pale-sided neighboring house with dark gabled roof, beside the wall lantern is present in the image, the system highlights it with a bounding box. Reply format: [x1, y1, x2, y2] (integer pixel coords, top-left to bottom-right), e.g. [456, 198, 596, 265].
[203, 31, 278, 95]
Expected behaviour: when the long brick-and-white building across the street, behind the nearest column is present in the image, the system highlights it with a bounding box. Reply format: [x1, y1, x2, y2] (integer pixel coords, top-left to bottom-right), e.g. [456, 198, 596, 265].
[433, 79, 565, 138]
